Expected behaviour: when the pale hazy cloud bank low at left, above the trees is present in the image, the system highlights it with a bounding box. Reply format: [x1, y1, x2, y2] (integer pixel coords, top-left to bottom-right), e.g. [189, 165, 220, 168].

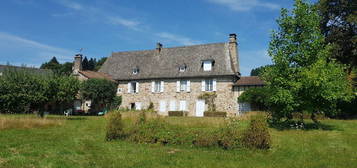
[0, 32, 75, 65]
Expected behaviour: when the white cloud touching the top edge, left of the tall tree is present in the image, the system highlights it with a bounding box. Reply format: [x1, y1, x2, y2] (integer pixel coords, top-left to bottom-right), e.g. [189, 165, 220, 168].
[208, 0, 280, 11]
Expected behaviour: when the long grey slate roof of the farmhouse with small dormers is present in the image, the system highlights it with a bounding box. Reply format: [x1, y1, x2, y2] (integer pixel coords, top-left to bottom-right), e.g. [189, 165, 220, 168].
[99, 43, 236, 80]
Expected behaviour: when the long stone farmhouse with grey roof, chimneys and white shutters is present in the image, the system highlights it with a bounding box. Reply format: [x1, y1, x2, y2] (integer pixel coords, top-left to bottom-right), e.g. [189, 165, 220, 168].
[73, 34, 264, 117]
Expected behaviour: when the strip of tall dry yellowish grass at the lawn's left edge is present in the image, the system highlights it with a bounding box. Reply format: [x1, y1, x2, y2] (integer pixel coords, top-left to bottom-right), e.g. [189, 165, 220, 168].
[0, 115, 64, 130]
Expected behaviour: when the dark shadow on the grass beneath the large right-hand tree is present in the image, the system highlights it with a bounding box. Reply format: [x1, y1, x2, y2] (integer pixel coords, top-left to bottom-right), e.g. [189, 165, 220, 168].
[269, 121, 342, 131]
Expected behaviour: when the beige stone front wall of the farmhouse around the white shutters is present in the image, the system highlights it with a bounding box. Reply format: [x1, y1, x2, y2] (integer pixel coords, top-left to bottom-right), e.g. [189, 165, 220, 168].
[117, 77, 238, 116]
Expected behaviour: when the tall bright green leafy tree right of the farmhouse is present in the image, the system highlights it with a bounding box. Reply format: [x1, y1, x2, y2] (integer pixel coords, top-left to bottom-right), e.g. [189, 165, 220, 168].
[263, 0, 352, 123]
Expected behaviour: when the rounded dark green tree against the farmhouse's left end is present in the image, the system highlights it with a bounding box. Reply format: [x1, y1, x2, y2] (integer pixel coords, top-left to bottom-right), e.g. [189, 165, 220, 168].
[80, 79, 117, 111]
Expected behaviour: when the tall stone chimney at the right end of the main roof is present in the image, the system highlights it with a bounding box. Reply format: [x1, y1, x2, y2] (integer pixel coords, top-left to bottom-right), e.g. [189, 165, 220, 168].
[229, 33, 240, 74]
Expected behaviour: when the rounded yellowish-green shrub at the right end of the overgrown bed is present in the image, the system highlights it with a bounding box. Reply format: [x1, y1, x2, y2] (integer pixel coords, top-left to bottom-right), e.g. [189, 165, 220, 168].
[242, 115, 271, 149]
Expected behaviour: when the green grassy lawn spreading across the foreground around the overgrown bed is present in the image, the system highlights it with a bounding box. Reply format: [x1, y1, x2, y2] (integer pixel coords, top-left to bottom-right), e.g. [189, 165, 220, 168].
[0, 115, 357, 168]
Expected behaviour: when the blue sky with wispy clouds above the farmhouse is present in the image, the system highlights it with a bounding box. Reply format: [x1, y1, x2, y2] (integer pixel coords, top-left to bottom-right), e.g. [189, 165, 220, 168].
[0, 0, 293, 75]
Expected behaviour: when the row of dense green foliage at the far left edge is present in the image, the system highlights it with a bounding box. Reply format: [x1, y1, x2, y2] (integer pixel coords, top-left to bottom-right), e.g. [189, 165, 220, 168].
[0, 69, 79, 113]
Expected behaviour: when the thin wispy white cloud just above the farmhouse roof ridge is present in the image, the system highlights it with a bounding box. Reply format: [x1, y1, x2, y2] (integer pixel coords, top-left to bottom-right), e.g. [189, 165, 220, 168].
[156, 32, 201, 45]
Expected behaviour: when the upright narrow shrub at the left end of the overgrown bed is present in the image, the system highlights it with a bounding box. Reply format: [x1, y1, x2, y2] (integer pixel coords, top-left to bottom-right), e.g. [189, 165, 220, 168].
[105, 111, 125, 141]
